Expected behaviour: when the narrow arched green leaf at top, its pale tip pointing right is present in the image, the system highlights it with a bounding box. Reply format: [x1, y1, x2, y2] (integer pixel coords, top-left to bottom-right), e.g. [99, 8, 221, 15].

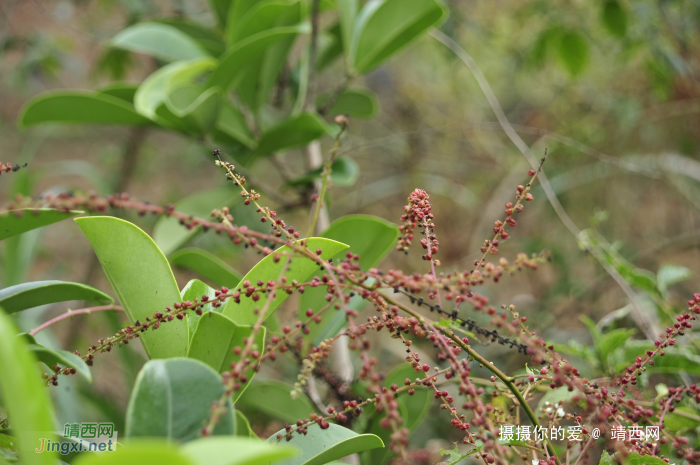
[208, 24, 310, 93]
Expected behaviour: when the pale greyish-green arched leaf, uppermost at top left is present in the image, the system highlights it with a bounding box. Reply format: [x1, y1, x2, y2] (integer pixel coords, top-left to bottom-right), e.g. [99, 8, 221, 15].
[107, 23, 208, 61]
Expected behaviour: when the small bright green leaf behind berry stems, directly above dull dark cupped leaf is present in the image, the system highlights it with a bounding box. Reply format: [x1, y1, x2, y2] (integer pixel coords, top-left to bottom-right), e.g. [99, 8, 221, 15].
[187, 312, 265, 402]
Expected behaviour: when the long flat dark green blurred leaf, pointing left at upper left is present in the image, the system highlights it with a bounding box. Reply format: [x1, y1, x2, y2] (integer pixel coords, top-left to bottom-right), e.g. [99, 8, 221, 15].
[19, 91, 153, 127]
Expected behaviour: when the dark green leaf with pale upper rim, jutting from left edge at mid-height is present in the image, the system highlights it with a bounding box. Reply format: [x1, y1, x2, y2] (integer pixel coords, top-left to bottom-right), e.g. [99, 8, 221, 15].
[0, 281, 114, 313]
